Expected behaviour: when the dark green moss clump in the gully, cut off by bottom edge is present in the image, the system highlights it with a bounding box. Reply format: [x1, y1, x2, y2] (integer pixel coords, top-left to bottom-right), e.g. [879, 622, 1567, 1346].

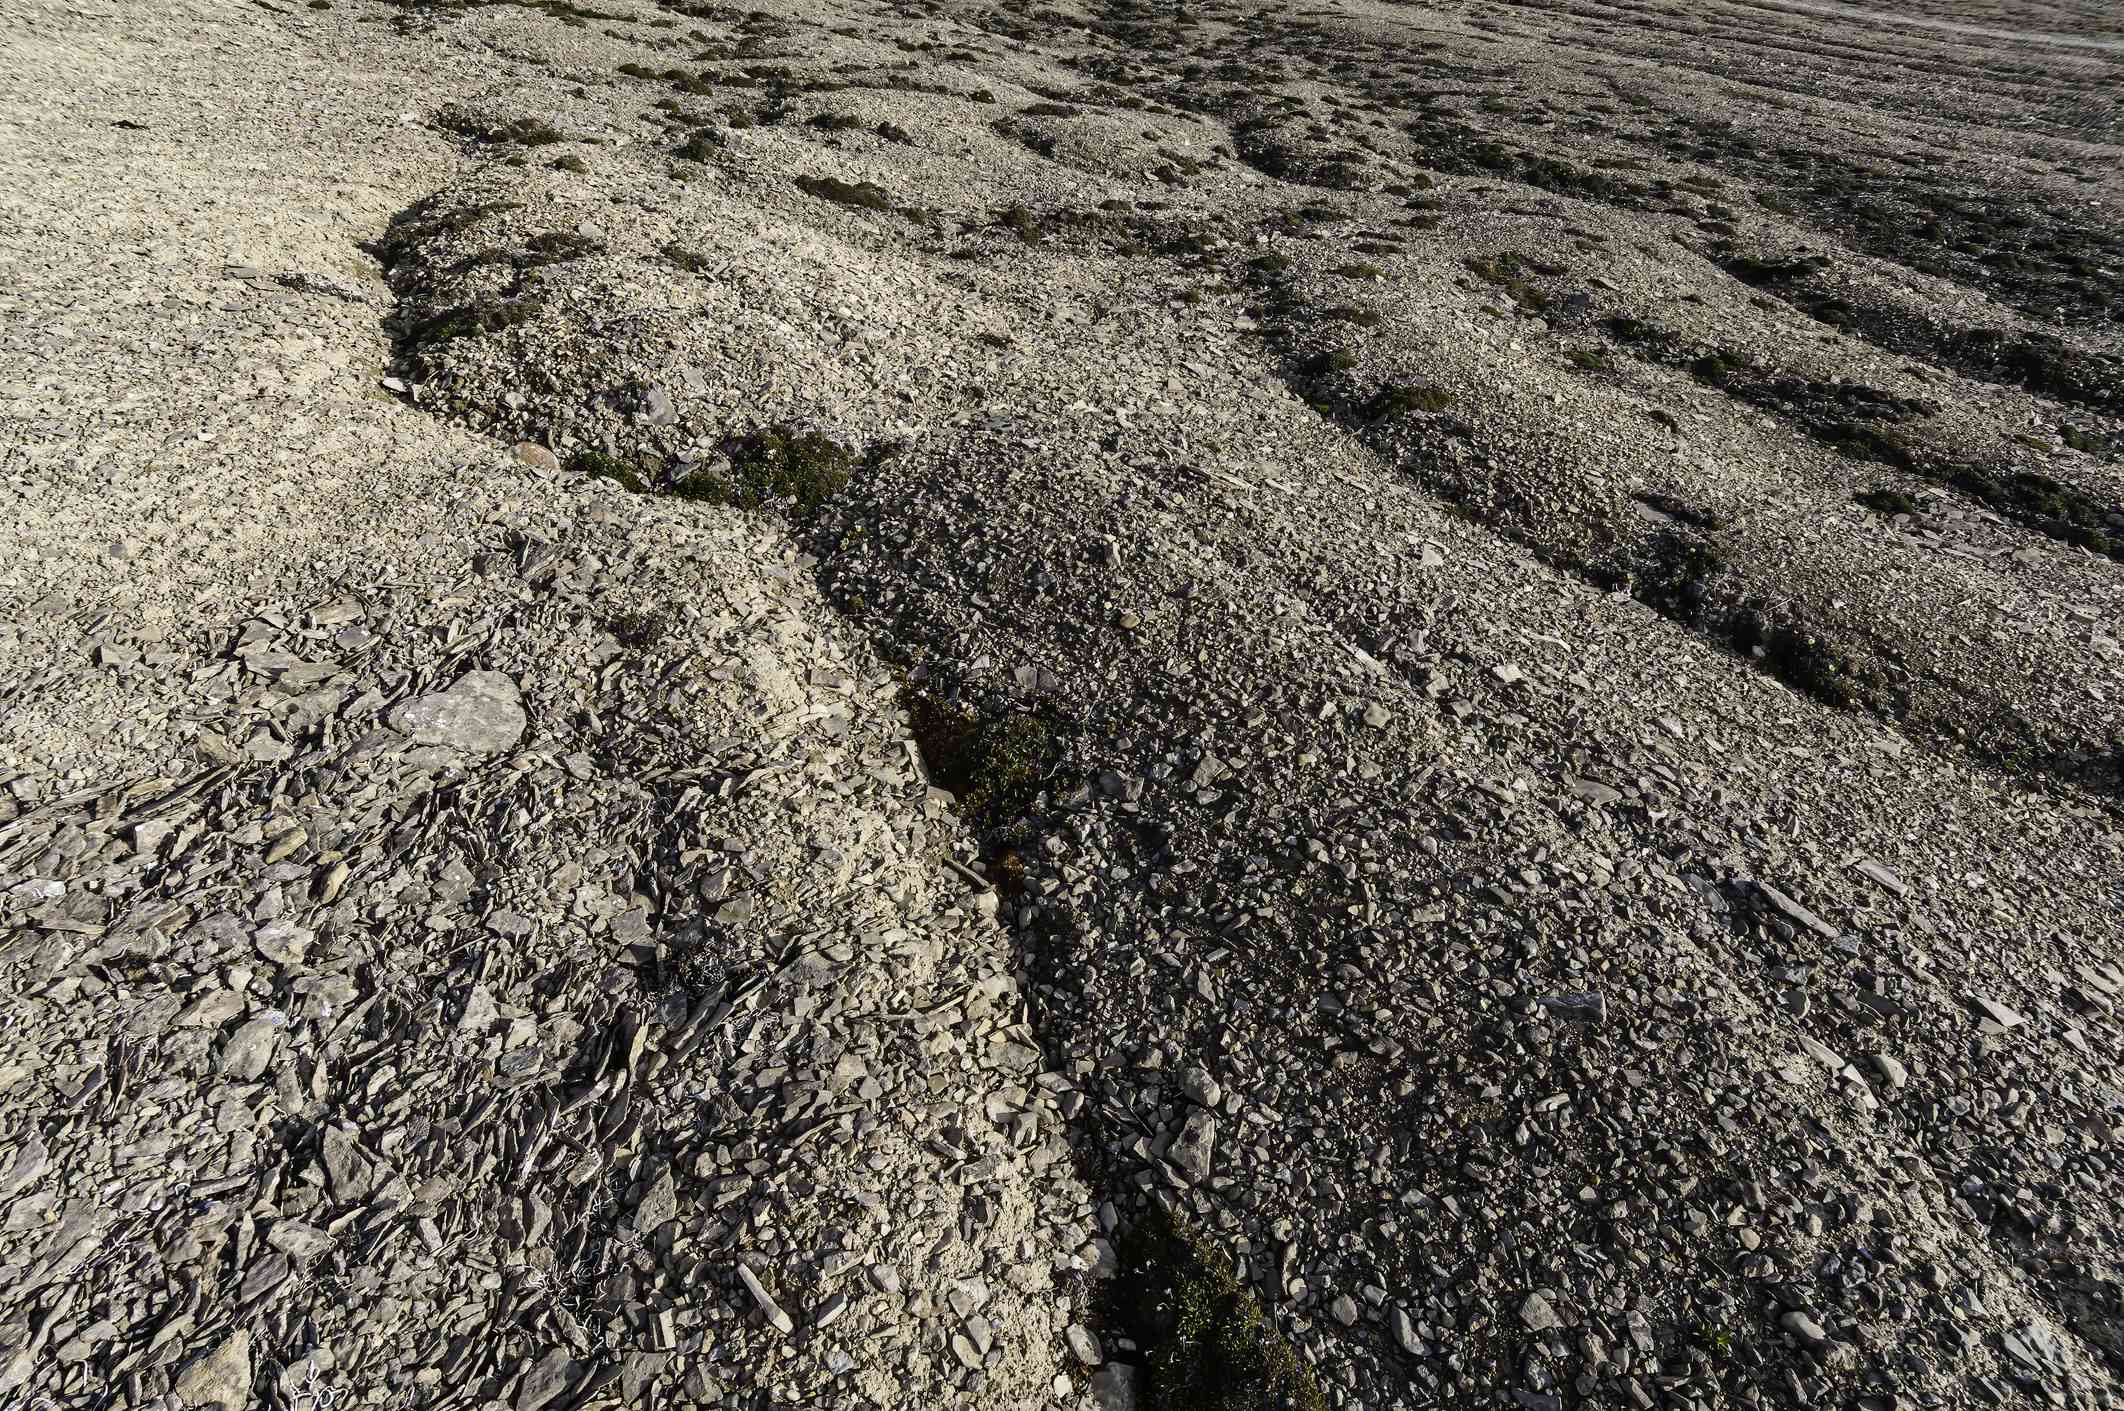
[1107, 1209, 1328, 1411]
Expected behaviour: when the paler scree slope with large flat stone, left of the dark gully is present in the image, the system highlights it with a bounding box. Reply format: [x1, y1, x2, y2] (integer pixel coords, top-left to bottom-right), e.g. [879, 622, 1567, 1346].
[0, 4, 1102, 1411]
